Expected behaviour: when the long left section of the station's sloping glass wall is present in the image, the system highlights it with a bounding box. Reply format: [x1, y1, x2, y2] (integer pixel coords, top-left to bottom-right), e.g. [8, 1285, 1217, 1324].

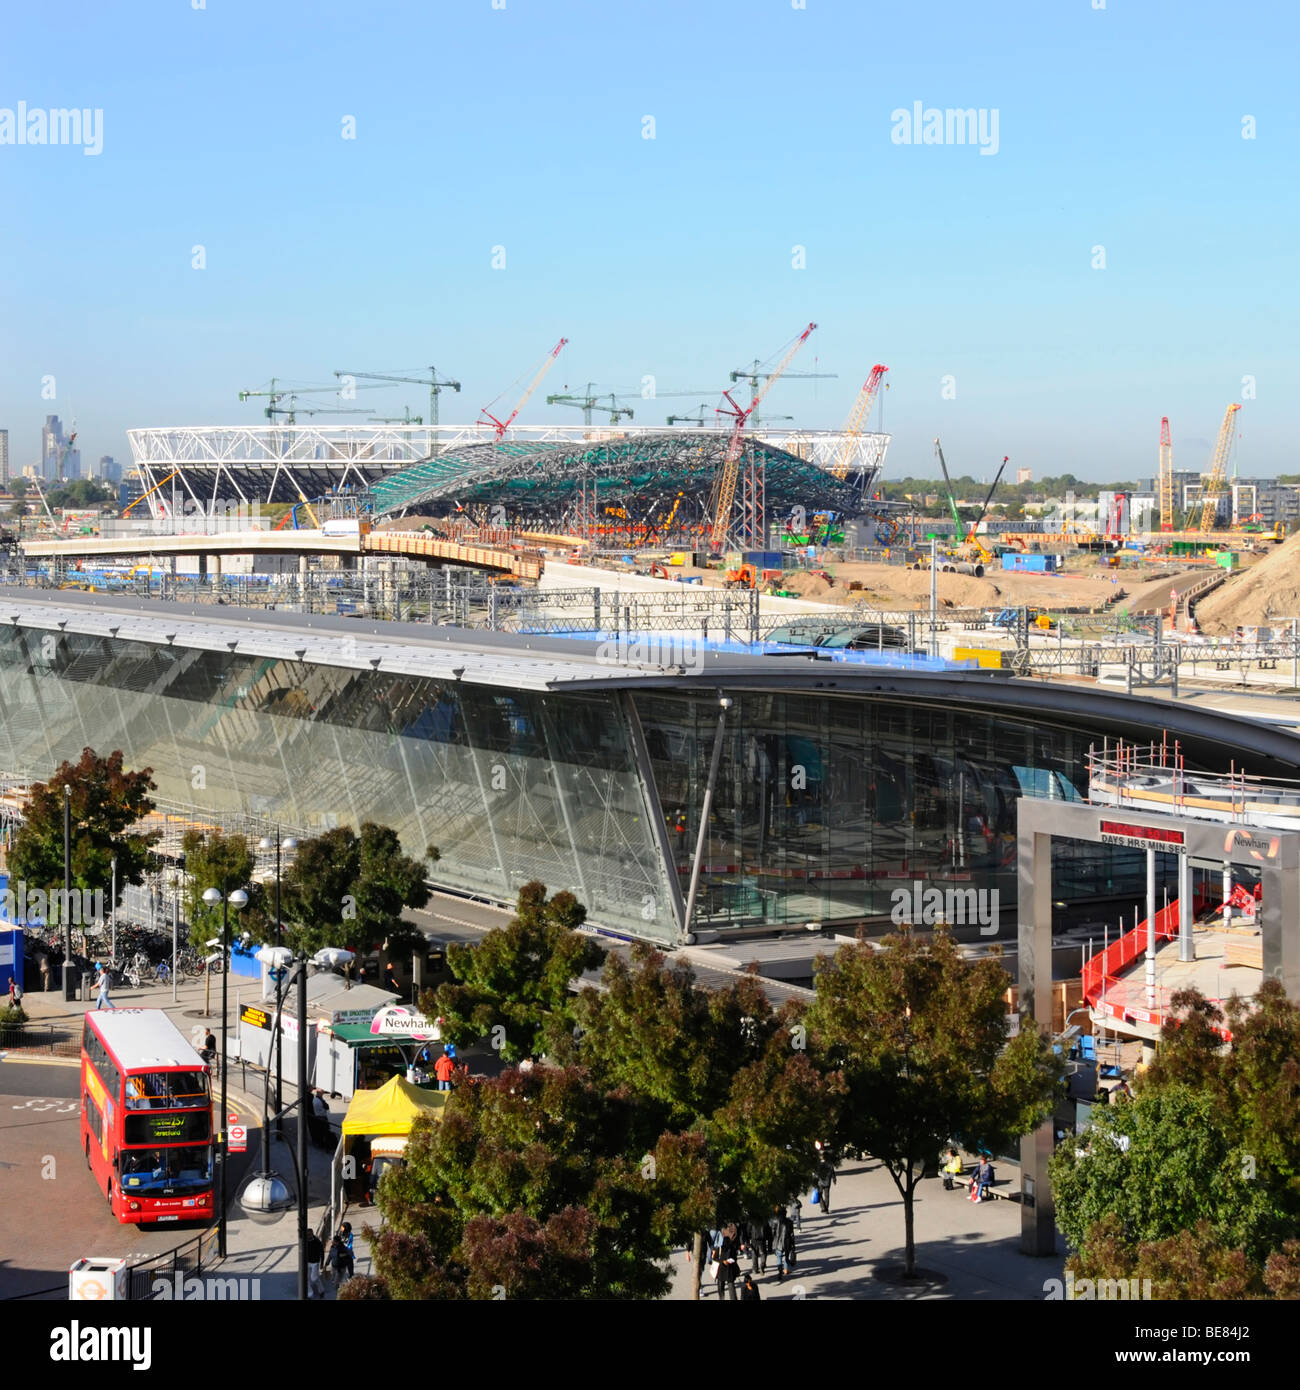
[0, 628, 686, 942]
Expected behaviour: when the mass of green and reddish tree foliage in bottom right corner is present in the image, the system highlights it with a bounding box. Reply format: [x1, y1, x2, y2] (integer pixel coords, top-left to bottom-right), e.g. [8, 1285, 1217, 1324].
[1050, 980, 1300, 1298]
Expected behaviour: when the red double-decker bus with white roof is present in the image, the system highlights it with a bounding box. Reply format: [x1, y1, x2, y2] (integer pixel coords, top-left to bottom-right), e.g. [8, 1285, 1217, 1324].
[81, 1009, 213, 1222]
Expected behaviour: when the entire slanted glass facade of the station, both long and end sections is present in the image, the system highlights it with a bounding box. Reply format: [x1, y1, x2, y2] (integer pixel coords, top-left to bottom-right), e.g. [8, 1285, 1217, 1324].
[0, 626, 1229, 942]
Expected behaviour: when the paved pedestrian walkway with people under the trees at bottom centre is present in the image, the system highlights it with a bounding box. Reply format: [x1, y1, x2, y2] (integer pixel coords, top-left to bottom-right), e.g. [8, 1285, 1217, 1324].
[669, 1159, 1065, 1301]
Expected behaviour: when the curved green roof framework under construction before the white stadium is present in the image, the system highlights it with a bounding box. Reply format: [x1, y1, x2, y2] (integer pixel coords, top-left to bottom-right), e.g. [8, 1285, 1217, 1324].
[371, 430, 869, 523]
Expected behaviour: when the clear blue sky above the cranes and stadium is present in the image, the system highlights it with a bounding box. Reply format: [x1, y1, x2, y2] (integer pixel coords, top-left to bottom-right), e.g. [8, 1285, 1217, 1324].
[0, 0, 1300, 478]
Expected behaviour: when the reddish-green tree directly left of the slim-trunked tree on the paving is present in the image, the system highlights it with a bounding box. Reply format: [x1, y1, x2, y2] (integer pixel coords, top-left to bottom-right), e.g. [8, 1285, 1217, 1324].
[574, 945, 837, 1297]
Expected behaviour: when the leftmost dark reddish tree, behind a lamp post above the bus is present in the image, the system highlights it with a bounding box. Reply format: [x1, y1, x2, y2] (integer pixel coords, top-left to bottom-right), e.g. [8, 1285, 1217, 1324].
[8, 748, 160, 920]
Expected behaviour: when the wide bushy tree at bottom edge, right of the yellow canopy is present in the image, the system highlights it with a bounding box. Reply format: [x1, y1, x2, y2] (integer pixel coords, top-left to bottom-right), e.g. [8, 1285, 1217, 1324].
[371, 1066, 681, 1300]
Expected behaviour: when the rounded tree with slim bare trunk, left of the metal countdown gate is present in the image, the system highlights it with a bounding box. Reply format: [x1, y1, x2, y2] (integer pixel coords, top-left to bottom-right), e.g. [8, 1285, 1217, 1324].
[806, 931, 1061, 1277]
